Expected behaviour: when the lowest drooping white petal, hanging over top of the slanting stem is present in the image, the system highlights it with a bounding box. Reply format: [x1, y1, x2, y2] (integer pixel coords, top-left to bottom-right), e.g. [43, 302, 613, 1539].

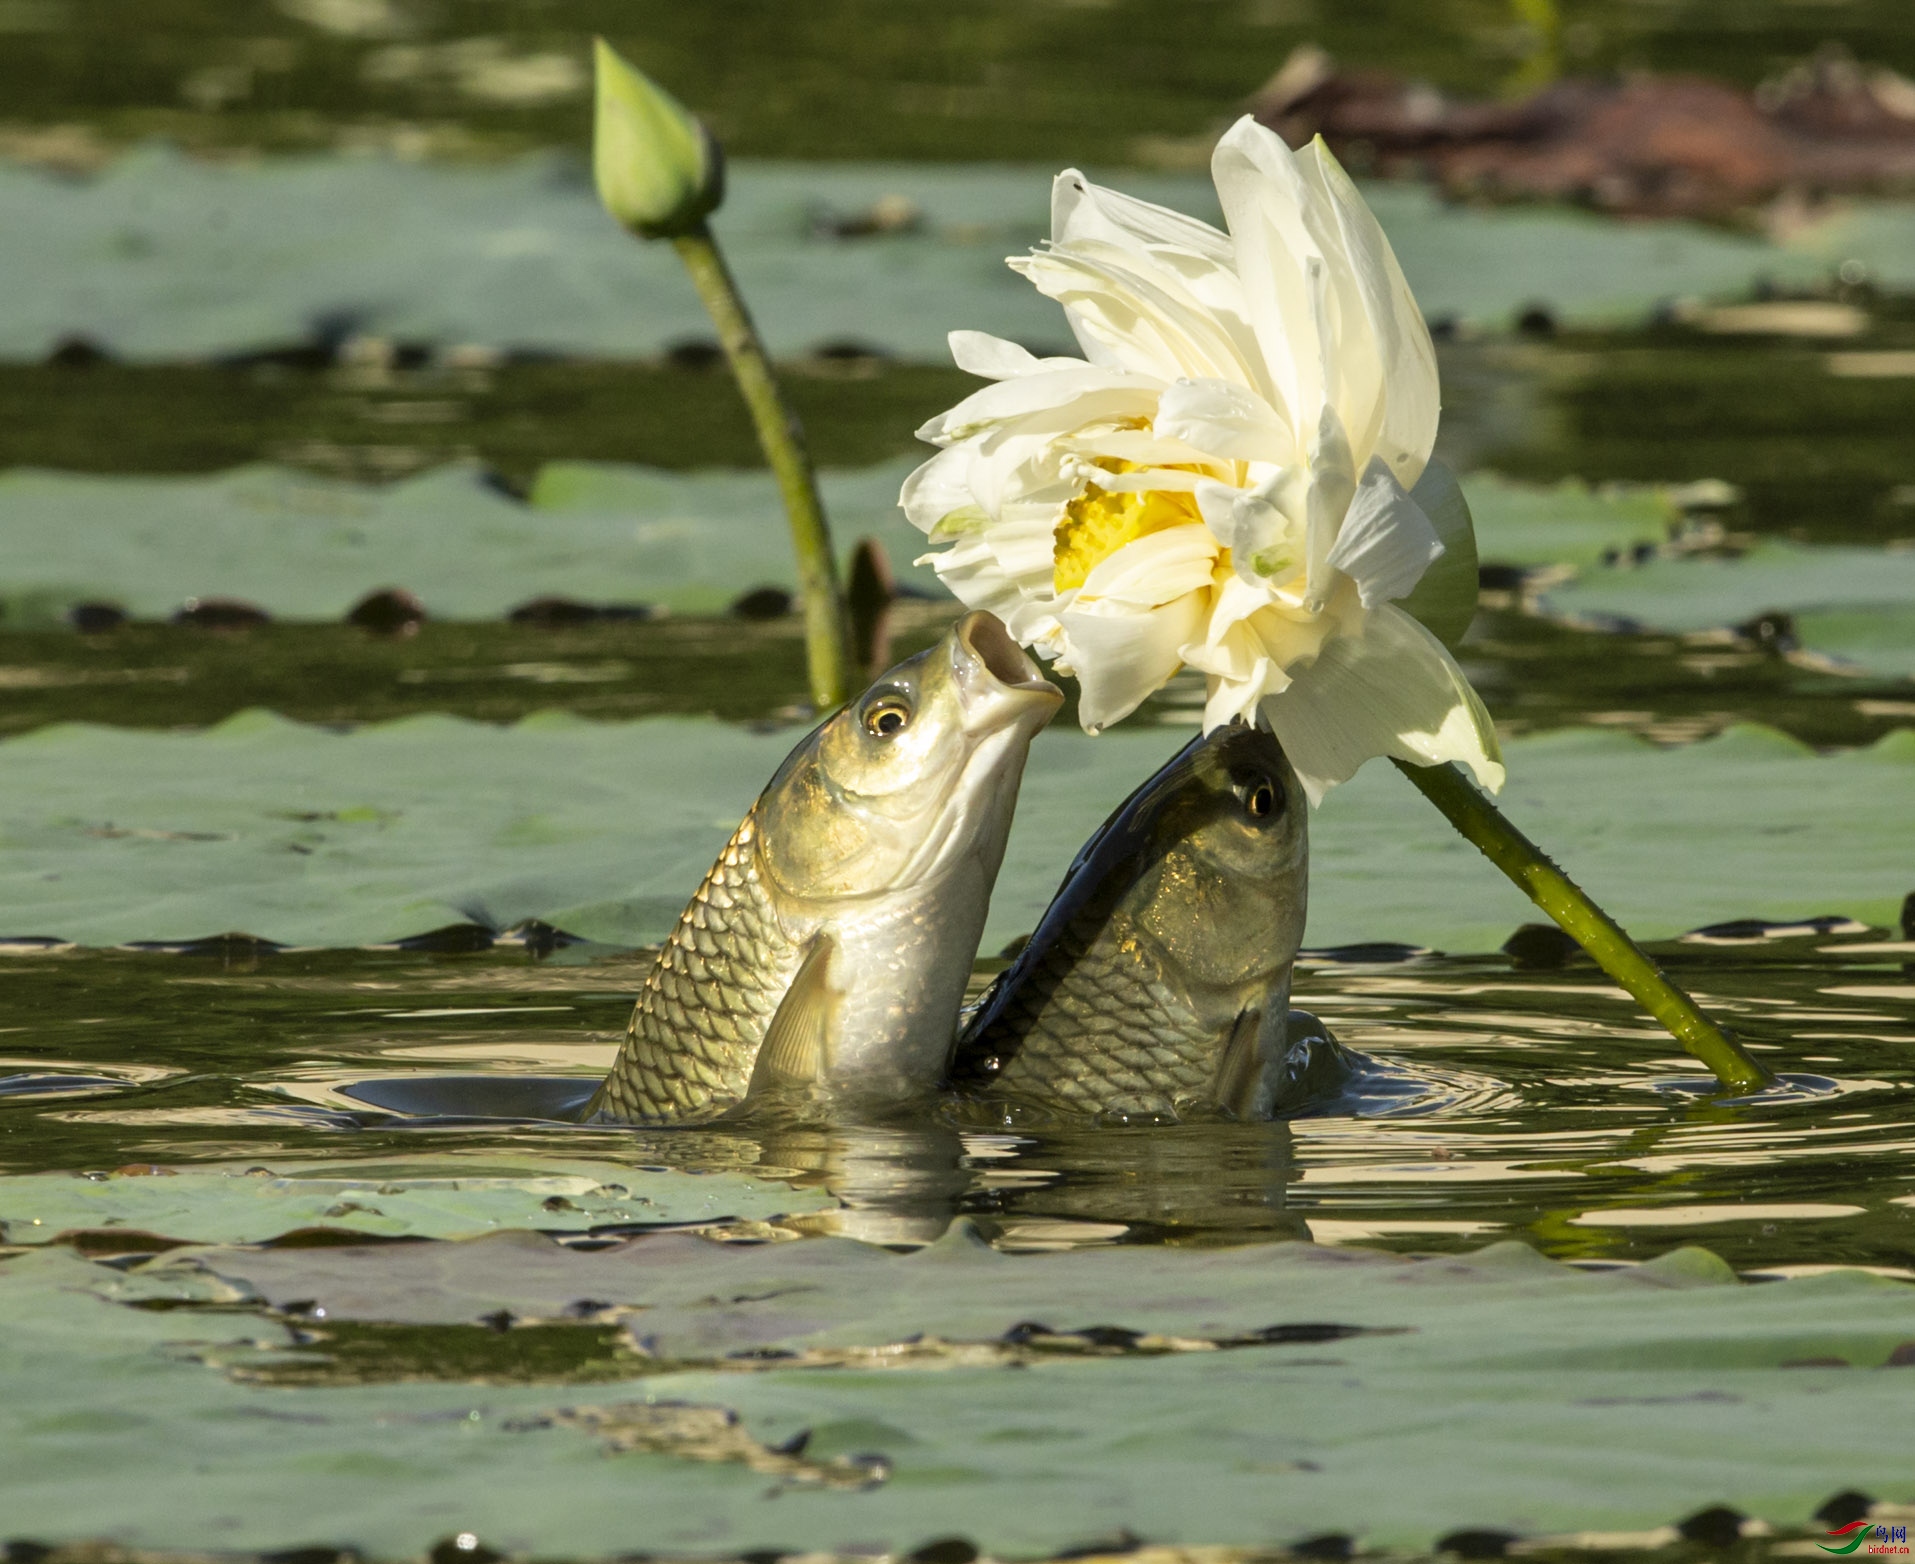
[1262, 603, 1503, 802]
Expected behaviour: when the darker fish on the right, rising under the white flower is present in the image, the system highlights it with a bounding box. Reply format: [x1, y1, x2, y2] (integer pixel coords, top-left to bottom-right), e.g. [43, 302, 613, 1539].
[950, 724, 1348, 1122]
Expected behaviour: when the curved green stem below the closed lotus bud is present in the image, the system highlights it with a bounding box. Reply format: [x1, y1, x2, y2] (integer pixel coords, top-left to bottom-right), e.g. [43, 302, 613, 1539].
[672, 222, 850, 712]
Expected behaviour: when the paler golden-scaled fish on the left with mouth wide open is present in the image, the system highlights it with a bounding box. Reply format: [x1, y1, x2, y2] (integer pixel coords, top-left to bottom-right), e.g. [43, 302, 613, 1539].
[586, 613, 1063, 1124]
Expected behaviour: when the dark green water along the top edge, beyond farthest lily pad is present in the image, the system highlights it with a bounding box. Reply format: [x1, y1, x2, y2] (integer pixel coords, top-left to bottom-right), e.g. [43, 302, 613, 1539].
[11, 0, 1915, 163]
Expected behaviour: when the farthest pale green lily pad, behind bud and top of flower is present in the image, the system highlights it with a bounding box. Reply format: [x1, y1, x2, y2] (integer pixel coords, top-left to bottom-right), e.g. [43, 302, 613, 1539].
[0, 147, 1876, 362]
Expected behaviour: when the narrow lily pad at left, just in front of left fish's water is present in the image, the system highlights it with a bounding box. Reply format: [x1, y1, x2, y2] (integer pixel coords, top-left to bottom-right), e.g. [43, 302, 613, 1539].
[0, 1156, 831, 1244]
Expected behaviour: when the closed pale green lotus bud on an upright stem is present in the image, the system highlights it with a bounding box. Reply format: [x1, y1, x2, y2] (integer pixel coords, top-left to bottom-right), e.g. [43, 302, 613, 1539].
[592, 38, 724, 239]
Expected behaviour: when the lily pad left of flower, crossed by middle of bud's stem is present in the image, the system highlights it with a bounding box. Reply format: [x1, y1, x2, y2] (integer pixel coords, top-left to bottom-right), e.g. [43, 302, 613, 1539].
[0, 451, 944, 624]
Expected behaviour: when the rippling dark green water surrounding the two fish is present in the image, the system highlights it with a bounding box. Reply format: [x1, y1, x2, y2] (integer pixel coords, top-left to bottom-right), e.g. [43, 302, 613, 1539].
[0, 934, 1915, 1275]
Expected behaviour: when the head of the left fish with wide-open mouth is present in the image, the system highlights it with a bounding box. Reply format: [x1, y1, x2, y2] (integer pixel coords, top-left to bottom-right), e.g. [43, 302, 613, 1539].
[758, 613, 1063, 903]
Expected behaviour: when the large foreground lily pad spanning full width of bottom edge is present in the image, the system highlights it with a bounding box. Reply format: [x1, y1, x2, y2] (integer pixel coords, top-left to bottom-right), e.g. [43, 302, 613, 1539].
[0, 1235, 1915, 1556]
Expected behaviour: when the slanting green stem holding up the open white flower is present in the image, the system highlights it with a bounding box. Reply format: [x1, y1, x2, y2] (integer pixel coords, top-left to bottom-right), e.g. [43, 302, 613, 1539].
[1396, 760, 1769, 1093]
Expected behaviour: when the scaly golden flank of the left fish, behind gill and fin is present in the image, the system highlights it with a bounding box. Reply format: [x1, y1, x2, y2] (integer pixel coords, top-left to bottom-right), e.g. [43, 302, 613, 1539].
[586, 810, 804, 1122]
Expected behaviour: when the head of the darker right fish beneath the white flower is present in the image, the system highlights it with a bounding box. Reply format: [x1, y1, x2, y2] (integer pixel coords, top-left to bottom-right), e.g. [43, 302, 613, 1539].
[1126, 724, 1310, 988]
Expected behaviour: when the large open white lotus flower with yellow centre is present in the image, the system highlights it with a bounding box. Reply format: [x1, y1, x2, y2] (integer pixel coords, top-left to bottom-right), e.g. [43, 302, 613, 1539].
[900, 119, 1503, 800]
